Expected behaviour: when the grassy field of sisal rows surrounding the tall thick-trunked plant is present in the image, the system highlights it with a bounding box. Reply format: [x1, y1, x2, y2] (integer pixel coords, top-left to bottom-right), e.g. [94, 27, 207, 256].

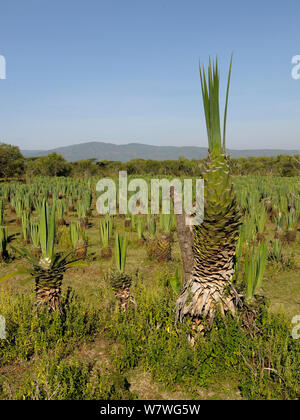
[0, 177, 300, 399]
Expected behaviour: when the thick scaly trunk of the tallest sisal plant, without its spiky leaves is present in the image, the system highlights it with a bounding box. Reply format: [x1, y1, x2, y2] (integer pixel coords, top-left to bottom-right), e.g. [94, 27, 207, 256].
[173, 158, 241, 326]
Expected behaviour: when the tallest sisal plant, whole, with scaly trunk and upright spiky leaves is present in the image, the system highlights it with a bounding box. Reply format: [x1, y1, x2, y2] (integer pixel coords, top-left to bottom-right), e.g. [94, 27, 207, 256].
[176, 55, 241, 325]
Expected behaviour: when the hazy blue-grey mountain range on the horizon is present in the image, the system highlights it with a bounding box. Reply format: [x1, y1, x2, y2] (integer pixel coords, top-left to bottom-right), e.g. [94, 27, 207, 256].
[21, 142, 299, 162]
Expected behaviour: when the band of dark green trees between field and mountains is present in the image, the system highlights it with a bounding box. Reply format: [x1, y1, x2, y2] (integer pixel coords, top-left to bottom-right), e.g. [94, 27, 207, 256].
[0, 143, 300, 179]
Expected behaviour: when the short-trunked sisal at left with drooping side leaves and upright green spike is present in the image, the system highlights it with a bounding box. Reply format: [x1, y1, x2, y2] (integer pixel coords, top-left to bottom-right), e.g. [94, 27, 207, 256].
[0, 200, 84, 312]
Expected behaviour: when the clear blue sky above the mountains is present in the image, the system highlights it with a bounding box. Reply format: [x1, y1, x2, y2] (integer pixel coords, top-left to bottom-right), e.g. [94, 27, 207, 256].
[0, 0, 300, 149]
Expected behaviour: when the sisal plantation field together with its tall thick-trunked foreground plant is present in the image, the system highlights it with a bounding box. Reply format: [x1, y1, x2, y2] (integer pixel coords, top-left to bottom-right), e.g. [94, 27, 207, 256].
[0, 59, 300, 400]
